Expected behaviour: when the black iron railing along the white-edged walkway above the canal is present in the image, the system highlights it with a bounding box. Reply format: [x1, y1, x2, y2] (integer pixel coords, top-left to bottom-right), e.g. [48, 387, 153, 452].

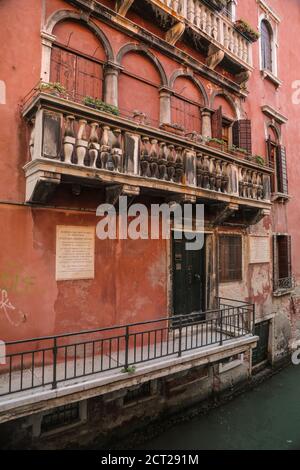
[0, 298, 255, 396]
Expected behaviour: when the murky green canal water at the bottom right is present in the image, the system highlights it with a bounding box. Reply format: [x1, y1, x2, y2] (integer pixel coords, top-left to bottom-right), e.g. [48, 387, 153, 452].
[142, 366, 300, 450]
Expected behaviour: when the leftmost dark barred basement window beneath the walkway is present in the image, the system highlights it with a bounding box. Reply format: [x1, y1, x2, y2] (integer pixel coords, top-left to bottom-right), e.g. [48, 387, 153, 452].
[41, 403, 80, 434]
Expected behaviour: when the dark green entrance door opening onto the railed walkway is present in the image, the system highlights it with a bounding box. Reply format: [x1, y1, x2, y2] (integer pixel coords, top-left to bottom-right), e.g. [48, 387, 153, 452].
[173, 234, 204, 315]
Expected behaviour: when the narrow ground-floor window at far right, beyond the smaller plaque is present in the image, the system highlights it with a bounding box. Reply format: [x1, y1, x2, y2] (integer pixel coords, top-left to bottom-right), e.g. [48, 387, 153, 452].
[273, 234, 293, 292]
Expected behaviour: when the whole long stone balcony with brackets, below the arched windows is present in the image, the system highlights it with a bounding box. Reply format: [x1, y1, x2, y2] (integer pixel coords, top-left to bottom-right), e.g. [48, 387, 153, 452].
[23, 92, 272, 224]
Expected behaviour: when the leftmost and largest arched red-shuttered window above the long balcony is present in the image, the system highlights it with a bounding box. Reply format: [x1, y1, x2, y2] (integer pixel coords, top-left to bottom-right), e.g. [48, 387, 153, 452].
[50, 21, 106, 102]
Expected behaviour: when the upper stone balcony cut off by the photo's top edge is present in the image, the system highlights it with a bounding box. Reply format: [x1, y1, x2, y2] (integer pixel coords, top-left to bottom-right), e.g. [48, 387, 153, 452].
[116, 0, 253, 83]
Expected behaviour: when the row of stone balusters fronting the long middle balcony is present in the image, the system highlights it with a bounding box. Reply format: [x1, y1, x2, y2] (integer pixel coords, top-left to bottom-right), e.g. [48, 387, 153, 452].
[29, 97, 270, 201]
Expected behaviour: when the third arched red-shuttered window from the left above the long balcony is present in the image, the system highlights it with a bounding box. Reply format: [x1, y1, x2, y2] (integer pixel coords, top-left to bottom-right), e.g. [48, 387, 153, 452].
[171, 77, 204, 134]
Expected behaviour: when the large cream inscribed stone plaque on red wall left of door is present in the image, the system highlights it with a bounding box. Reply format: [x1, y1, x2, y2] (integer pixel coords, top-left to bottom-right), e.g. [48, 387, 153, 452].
[56, 225, 95, 281]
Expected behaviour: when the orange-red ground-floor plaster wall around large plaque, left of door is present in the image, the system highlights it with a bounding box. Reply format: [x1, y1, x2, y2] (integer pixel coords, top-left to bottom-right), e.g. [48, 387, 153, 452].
[0, 205, 167, 340]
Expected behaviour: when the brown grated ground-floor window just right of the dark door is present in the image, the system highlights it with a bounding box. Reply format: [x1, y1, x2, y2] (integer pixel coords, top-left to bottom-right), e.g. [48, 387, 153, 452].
[219, 235, 243, 282]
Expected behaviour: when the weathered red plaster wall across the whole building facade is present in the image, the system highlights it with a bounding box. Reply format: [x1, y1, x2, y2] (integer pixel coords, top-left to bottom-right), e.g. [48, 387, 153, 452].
[0, 0, 300, 358]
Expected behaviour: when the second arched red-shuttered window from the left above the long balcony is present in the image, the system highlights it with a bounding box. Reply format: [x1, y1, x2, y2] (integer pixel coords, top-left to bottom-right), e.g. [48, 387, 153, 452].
[119, 51, 162, 127]
